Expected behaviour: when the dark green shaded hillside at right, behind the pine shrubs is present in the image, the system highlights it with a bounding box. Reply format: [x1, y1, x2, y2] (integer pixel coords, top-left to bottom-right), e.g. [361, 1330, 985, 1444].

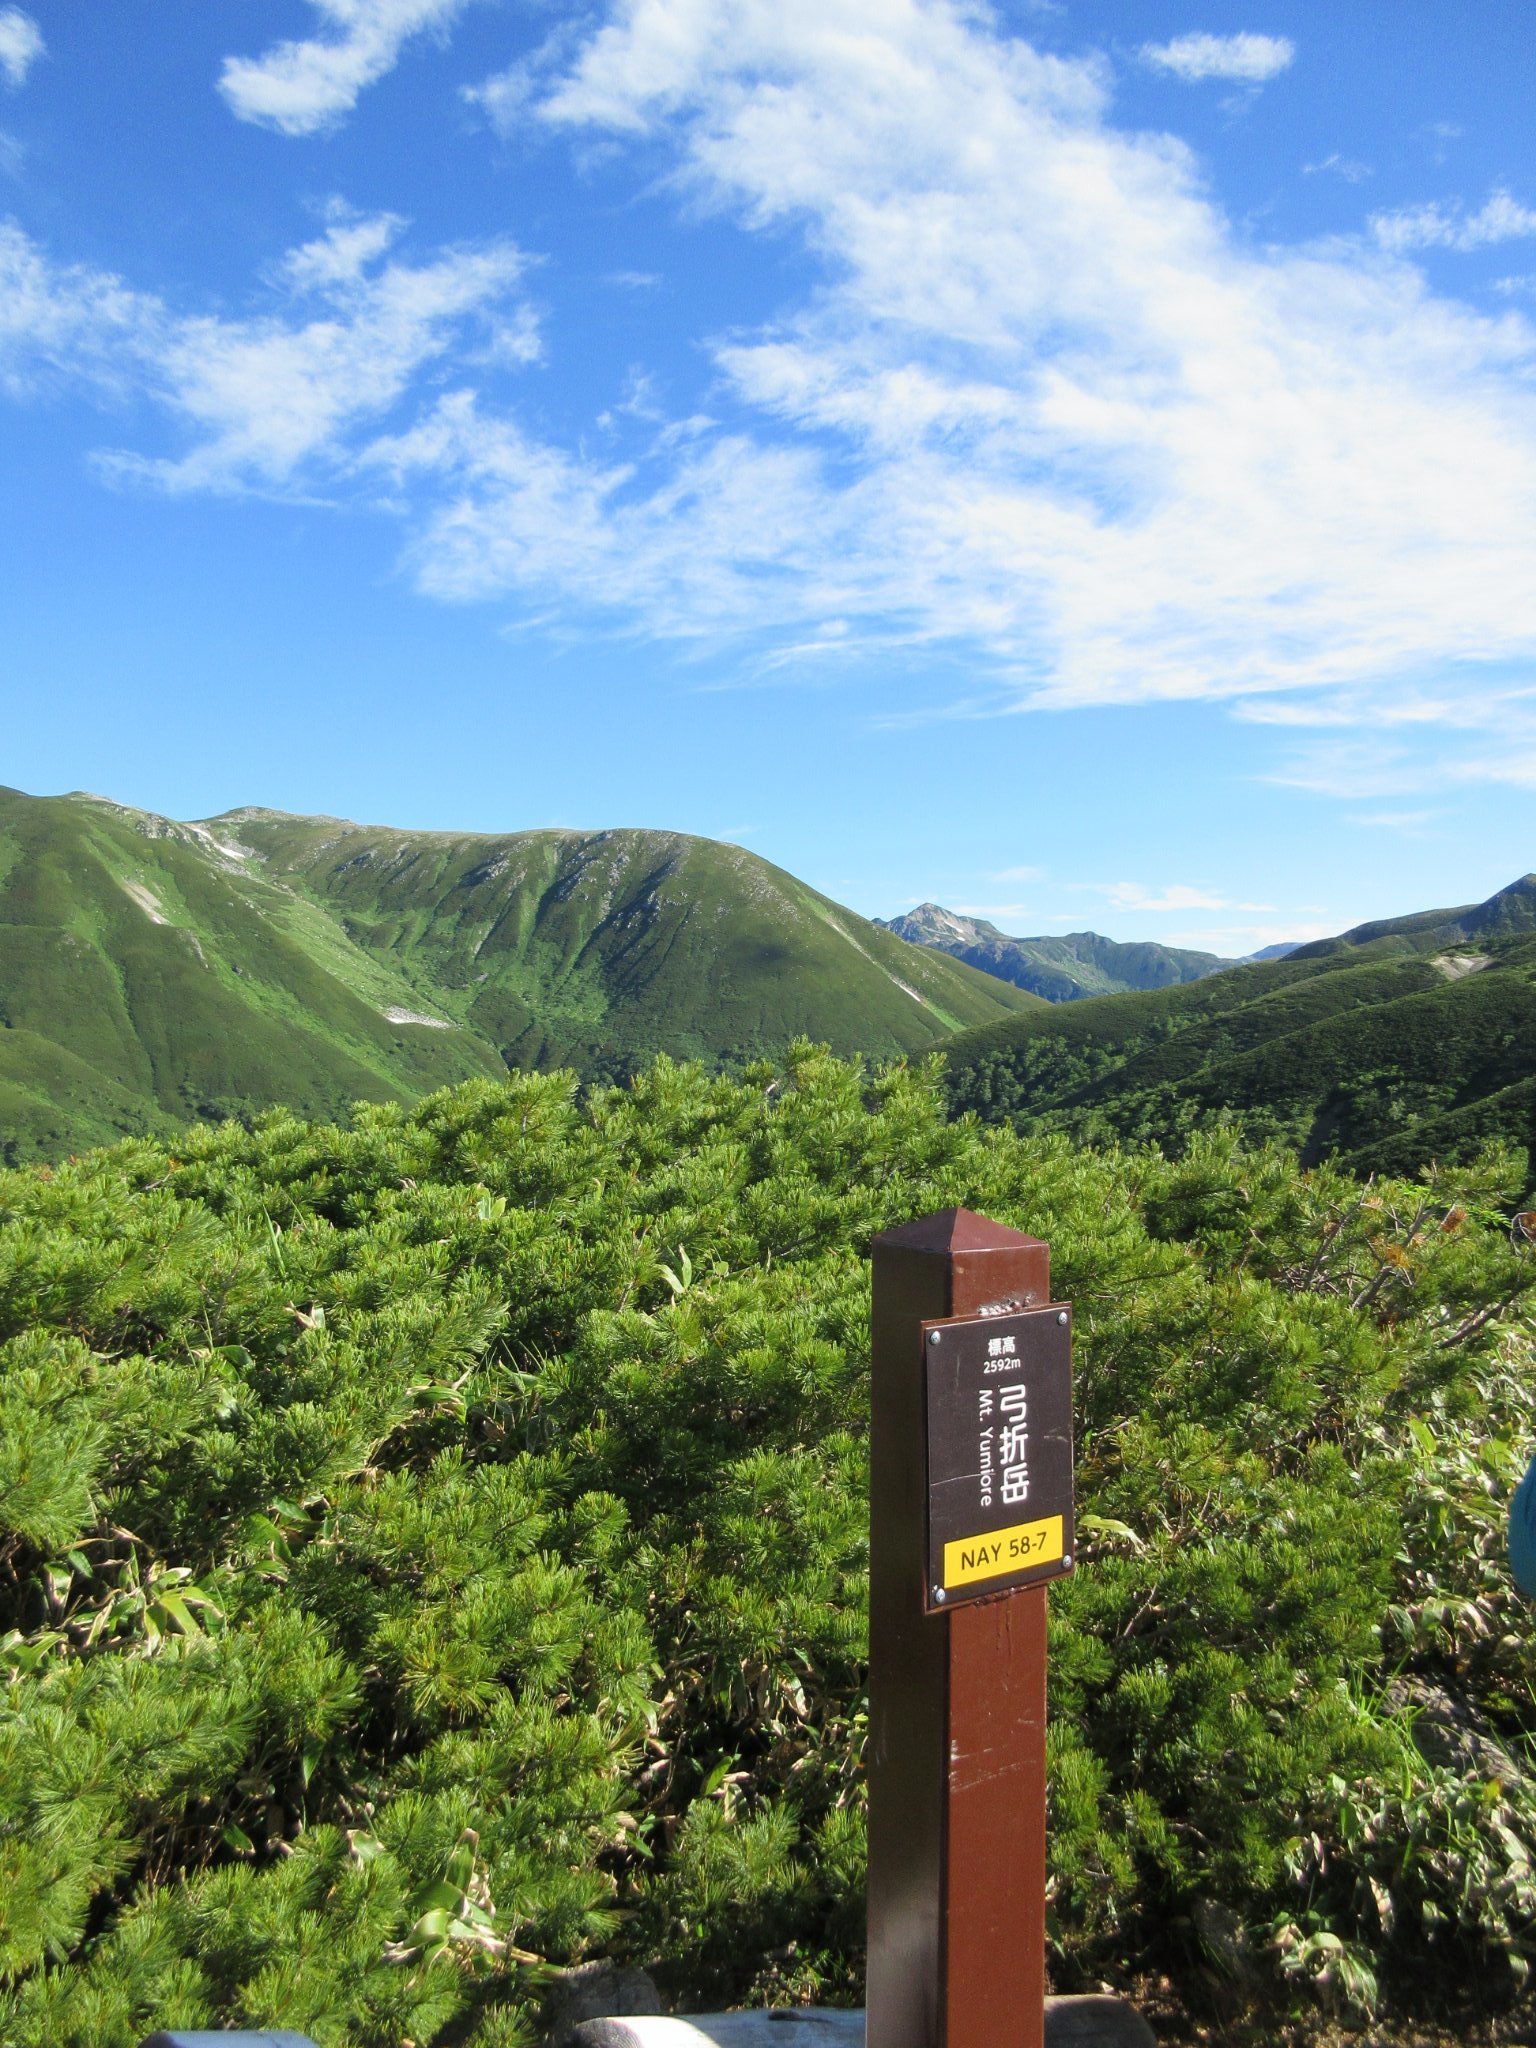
[946, 874, 1536, 1171]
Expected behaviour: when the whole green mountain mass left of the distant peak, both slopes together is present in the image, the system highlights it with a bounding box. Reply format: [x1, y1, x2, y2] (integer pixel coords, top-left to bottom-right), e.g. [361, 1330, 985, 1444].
[0, 791, 1030, 1161]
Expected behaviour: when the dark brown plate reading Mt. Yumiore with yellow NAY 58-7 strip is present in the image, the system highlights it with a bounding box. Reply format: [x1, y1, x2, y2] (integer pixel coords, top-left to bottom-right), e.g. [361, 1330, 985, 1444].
[922, 1303, 1073, 1614]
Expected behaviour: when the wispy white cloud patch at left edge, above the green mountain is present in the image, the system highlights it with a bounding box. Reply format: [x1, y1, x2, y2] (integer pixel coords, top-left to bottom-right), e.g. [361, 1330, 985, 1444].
[0, 209, 522, 492]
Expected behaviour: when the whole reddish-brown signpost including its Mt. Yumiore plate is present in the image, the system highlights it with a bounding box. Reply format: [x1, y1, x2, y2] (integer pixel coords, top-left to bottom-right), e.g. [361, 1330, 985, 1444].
[866, 1208, 1073, 2048]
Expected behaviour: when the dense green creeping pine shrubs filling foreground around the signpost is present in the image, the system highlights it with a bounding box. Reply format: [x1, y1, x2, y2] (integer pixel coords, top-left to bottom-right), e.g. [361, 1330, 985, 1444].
[0, 1047, 1536, 2048]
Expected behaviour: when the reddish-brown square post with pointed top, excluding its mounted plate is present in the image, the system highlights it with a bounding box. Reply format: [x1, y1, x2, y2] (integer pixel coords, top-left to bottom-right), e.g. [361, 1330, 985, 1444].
[864, 1208, 1051, 2048]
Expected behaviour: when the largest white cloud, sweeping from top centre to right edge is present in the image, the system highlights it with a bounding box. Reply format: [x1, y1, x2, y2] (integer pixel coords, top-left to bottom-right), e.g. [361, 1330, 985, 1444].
[382, 0, 1536, 737]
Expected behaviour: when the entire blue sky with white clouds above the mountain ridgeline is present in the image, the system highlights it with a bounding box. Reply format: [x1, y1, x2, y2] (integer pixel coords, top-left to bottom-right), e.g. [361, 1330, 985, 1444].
[0, 0, 1536, 952]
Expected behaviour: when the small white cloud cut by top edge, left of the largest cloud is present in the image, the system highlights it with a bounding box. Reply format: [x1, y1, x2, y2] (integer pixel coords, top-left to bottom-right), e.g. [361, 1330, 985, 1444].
[219, 0, 469, 135]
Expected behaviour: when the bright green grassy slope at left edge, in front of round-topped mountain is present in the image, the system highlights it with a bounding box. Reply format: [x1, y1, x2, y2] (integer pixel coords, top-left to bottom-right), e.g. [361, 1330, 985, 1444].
[0, 791, 500, 1157]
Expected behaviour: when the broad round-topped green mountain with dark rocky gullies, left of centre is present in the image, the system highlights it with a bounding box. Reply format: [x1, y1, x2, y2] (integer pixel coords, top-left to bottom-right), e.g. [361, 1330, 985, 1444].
[213, 811, 1032, 1075]
